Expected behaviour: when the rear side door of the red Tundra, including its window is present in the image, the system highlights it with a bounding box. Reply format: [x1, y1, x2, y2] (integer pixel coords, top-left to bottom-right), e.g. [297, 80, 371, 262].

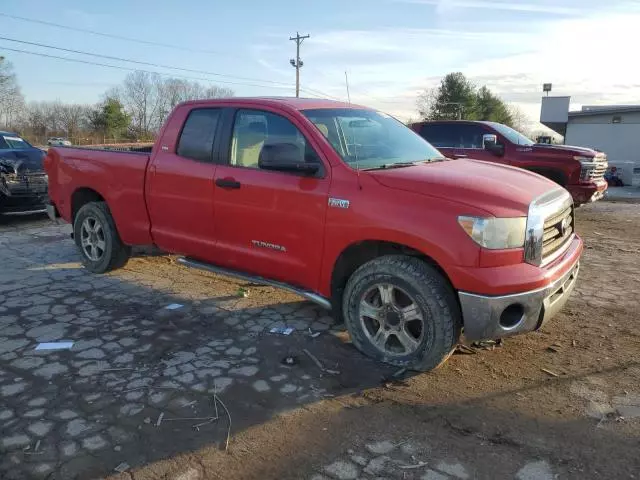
[147, 108, 224, 261]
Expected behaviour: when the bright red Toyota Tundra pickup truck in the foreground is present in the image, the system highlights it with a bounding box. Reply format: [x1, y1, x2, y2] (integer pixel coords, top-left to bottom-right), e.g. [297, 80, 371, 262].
[45, 98, 583, 370]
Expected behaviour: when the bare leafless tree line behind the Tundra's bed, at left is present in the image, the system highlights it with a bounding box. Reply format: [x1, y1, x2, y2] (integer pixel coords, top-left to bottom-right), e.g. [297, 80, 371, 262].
[0, 57, 234, 144]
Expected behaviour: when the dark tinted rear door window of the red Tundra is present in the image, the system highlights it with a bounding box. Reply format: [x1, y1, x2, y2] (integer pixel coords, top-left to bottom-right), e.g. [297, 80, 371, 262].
[176, 108, 220, 163]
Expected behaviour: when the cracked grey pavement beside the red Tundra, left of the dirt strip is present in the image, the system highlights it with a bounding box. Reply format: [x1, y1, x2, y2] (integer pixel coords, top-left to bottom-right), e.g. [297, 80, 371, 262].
[0, 219, 394, 479]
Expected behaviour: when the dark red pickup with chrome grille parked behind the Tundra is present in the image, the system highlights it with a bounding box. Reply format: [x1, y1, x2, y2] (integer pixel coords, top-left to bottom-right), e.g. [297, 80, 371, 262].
[411, 121, 607, 205]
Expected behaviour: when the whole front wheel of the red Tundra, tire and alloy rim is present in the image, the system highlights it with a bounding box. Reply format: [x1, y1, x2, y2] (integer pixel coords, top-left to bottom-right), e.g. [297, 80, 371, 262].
[343, 255, 461, 371]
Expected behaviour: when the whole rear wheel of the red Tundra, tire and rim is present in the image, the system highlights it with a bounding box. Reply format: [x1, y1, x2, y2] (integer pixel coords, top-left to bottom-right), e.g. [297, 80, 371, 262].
[73, 202, 131, 273]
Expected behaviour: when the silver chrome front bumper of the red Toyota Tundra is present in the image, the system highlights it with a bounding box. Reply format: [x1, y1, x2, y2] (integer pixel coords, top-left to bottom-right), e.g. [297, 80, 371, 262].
[458, 261, 580, 341]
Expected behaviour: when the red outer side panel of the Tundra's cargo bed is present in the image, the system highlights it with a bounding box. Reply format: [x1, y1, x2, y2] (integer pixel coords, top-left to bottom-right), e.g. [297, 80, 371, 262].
[44, 147, 152, 245]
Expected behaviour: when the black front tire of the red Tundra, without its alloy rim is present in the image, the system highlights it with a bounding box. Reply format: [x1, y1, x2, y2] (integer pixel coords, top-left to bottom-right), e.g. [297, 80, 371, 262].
[342, 255, 462, 371]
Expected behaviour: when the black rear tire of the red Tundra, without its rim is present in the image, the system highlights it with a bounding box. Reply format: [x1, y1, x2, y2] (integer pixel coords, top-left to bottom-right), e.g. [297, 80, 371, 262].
[73, 202, 131, 273]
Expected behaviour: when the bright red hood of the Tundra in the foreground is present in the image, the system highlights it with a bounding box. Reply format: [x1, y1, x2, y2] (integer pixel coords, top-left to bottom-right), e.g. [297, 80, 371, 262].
[367, 159, 559, 217]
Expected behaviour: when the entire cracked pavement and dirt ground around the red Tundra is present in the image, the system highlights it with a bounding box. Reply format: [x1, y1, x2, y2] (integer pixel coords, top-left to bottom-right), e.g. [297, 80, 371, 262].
[0, 202, 640, 480]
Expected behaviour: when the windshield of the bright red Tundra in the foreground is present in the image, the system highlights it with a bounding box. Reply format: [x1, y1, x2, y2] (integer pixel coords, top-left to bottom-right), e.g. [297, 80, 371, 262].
[302, 108, 444, 170]
